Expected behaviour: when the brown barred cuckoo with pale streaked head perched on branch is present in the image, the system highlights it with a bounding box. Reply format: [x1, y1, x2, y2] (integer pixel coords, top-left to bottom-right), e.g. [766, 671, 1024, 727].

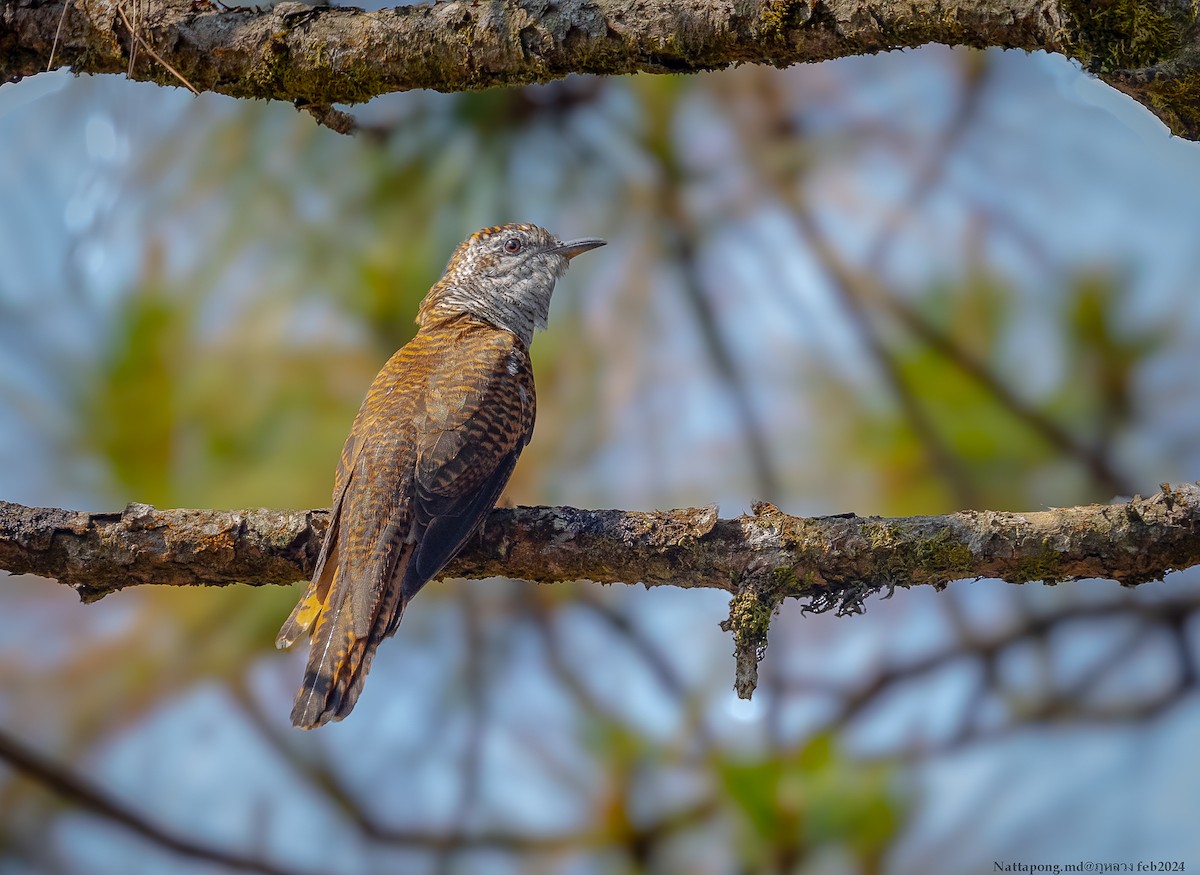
[275, 224, 605, 729]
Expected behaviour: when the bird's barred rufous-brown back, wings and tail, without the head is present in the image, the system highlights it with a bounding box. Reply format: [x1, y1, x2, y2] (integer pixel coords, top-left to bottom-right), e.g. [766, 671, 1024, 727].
[280, 318, 534, 729]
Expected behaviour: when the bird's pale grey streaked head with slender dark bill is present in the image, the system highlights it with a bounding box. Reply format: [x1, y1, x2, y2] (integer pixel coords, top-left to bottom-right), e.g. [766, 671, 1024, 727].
[416, 224, 605, 347]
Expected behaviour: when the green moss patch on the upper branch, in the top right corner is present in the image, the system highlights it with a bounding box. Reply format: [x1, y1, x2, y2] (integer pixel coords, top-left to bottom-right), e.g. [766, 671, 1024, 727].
[1063, 0, 1196, 73]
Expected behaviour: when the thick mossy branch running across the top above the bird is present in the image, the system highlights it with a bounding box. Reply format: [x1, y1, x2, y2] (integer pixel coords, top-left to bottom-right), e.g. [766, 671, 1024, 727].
[0, 0, 1200, 139]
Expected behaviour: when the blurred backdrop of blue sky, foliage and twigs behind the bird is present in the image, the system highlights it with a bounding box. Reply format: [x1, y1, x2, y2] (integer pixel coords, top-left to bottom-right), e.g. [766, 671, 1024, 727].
[0, 39, 1200, 875]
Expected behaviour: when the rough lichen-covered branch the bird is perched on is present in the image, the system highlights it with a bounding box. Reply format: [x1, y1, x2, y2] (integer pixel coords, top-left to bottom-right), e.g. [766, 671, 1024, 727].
[0, 484, 1200, 696]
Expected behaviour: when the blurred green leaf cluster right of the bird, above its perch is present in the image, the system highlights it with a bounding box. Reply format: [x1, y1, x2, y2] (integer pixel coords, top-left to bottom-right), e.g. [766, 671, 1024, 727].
[824, 267, 1169, 515]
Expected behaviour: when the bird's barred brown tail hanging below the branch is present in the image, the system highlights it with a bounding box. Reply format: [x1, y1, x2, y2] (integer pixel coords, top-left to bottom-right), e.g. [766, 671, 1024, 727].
[280, 550, 408, 729]
